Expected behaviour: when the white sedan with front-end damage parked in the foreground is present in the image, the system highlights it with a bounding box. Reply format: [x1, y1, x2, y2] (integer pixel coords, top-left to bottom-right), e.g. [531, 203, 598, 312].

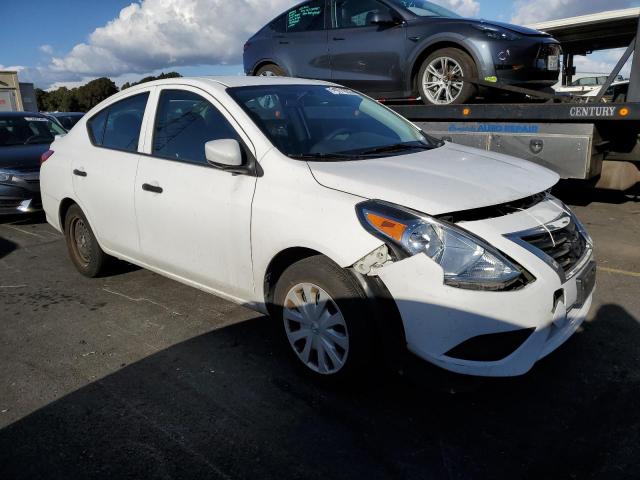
[40, 77, 595, 378]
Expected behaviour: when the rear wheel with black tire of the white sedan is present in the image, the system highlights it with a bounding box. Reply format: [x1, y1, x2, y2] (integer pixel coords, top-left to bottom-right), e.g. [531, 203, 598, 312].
[64, 205, 108, 278]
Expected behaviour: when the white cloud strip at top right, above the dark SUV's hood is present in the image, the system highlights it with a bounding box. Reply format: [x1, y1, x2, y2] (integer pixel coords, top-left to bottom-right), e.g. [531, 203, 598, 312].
[511, 0, 632, 25]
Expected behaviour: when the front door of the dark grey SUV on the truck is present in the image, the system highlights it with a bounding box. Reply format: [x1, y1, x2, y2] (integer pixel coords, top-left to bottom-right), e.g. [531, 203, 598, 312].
[329, 0, 406, 93]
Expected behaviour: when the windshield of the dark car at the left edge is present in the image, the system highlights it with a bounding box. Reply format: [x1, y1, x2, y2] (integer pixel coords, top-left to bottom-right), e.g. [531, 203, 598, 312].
[0, 115, 67, 147]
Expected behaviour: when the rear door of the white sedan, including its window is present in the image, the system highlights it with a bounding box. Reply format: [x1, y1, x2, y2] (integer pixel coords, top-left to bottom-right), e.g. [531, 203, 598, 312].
[69, 90, 149, 257]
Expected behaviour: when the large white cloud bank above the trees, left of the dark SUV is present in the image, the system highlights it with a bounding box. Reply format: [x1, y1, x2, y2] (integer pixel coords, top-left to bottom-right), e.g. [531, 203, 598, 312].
[25, 0, 296, 86]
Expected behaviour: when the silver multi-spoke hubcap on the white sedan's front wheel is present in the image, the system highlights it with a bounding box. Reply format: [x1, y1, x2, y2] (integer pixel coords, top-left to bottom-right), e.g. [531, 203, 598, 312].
[282, 283, 349, 375]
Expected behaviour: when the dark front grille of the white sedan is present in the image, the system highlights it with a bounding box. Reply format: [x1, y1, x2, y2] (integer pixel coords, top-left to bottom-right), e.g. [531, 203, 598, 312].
[522, 219, 587, 273]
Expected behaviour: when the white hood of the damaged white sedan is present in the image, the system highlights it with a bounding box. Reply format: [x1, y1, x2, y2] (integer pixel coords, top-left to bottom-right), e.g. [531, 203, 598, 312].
[308, 143, 558, 215]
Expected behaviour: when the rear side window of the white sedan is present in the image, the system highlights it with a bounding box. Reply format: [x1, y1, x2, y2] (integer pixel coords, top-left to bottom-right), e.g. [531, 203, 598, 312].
[87, 92, 149, 152]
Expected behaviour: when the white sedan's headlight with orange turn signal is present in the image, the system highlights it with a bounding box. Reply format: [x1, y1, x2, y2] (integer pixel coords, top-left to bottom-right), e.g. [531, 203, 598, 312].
[356, 200, 522, 290]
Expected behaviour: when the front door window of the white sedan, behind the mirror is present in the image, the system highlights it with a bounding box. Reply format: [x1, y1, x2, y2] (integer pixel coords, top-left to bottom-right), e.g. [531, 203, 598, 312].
[152, 90, 241, 165]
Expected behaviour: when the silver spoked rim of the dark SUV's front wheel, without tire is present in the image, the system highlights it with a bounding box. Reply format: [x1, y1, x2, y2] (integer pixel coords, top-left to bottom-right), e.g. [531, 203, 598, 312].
[422, 57, 464, 104]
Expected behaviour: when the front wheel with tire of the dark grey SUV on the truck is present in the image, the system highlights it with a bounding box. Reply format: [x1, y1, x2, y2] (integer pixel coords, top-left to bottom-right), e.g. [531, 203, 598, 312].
[417, 48, 477, 105]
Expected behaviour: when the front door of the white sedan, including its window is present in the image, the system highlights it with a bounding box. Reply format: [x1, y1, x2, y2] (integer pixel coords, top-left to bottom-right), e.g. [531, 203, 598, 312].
[135, 86, 256, 298]
